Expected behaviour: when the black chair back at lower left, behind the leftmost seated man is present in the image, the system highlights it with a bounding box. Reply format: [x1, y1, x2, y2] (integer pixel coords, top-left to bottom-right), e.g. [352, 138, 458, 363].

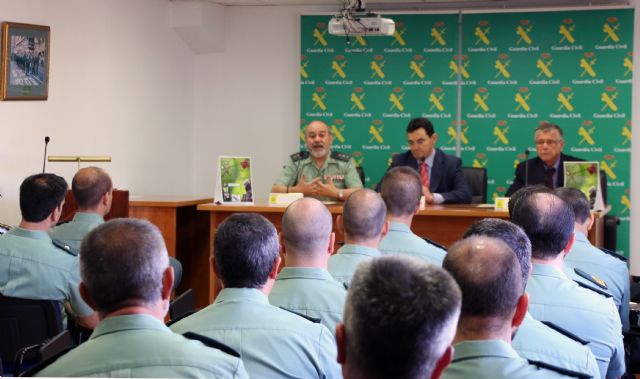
[0, 295, 63, 370]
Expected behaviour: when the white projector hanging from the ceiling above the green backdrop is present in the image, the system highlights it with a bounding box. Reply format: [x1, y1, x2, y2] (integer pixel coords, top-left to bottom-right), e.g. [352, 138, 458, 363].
[329, 13, 396, 37]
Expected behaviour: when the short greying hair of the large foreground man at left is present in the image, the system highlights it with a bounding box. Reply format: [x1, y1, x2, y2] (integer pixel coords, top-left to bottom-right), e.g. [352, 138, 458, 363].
[80, 218, 169, 313]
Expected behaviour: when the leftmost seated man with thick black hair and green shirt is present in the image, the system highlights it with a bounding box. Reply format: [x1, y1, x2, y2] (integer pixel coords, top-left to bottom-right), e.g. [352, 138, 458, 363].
[0, 174, 98, 329]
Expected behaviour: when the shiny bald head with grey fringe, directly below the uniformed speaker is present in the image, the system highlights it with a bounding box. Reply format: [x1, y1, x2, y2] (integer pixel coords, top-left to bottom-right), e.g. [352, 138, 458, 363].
[282, 197, 333, 258]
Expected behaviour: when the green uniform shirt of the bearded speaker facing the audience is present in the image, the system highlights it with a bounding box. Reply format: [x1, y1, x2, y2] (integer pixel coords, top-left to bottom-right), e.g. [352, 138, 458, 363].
[275, 153, 362, 201]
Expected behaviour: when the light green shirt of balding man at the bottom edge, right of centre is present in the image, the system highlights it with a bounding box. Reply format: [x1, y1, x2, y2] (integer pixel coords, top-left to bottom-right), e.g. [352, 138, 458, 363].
[442, 340, 569, 379]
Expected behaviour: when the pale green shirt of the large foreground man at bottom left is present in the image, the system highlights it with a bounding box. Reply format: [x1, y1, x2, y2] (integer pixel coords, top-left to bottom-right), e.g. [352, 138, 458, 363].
[36, 314, 249, 378]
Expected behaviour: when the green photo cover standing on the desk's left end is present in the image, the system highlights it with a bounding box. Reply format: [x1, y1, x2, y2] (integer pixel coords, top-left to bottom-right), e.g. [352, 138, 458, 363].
[215, 157, 253, 204]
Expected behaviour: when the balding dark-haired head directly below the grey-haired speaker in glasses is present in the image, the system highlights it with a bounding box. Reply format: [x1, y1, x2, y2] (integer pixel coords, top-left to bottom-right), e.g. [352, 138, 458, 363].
[511, 192, 575, 260]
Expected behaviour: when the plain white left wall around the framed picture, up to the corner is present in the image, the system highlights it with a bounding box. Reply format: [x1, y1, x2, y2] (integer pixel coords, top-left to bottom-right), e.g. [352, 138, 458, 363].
[0, 0, 194, 224]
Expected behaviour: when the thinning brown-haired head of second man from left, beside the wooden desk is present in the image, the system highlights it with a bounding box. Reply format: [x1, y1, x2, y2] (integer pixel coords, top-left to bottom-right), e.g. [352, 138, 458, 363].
[71, 167, 113, 213]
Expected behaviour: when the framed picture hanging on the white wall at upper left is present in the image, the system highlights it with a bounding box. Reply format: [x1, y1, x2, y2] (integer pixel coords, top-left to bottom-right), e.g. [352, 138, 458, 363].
[0, 22, 51, 100]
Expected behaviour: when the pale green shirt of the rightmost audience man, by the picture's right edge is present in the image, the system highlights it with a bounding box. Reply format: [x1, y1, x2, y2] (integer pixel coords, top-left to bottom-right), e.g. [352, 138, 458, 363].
[564, 232, 631, 331]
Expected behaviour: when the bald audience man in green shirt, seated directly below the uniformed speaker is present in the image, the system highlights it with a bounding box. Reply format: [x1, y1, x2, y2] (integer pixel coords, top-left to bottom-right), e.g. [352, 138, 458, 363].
[269, 198, 347, 333]
